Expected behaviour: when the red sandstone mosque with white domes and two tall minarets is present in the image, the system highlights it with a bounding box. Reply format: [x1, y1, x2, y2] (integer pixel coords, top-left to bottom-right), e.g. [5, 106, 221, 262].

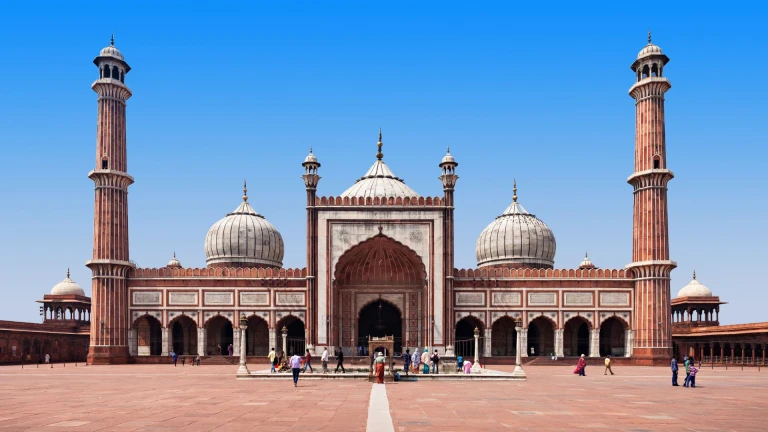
[0, 35, 768, 365]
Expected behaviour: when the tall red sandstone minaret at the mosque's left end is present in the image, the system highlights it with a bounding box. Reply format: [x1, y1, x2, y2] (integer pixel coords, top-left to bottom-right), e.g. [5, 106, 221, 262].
[86, 36, 133, 364]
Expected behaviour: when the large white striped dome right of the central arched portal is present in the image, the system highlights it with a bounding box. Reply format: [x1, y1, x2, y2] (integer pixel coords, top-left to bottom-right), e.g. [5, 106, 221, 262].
[475, 188, 556, 268]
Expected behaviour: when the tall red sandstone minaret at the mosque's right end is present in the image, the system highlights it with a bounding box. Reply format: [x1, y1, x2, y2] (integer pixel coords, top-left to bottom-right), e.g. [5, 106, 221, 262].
[627, 32, 677, 364]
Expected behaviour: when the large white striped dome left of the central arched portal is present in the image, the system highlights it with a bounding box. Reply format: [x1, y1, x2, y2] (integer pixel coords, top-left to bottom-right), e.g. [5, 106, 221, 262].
[205, 191, 284, 267]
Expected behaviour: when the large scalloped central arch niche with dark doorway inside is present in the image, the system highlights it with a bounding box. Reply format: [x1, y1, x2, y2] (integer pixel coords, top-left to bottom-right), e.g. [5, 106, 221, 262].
[329, 233, 432, 354]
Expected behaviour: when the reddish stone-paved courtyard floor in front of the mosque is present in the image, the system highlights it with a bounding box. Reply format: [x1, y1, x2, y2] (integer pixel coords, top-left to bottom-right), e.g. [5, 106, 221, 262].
[0, 365, 768, 432]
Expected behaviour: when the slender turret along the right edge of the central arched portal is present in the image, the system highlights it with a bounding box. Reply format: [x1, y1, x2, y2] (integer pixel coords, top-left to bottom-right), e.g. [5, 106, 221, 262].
[438, 147, 459, 356]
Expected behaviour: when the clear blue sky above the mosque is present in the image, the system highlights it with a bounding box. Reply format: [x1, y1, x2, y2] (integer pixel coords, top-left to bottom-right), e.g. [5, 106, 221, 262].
[0, 1, 768, 323]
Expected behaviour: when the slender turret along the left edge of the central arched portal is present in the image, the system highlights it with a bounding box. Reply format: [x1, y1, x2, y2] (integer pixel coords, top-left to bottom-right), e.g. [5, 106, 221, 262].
[301, 147, 320, 350]
